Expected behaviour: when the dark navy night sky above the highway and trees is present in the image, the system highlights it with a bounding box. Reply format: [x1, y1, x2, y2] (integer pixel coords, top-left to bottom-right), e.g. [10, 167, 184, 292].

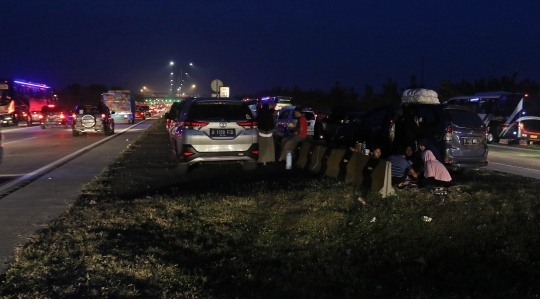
[0, 0, 540, 95]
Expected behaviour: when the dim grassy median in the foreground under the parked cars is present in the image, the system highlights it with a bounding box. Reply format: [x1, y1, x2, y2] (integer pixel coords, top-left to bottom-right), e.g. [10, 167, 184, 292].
[0, 120, 540, 299]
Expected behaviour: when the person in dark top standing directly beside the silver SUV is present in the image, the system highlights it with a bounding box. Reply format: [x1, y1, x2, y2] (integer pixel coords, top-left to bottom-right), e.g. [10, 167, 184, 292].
[257, 104, 276, 165]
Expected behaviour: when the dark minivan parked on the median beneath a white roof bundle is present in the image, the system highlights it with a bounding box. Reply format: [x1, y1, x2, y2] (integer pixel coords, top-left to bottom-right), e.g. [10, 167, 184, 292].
[350, 103, 488, 170]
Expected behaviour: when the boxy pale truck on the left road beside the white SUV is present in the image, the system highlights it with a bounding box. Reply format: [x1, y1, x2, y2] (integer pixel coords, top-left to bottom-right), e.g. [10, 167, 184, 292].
[102, 90, 136, 124]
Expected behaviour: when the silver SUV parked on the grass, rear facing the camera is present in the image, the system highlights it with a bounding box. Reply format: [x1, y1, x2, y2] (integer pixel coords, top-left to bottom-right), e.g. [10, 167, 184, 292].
[169, 98, 259, 173]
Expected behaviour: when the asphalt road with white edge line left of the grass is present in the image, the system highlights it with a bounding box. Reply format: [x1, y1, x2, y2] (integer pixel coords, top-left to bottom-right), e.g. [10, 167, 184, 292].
[0, 119, 155, 273]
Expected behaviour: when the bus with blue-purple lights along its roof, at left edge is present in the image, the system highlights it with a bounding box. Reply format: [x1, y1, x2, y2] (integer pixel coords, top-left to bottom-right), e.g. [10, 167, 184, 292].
[0, 79, 54, 124]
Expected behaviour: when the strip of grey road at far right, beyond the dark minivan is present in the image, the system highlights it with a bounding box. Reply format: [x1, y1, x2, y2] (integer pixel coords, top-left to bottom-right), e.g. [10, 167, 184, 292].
[486, 145, 540, 179]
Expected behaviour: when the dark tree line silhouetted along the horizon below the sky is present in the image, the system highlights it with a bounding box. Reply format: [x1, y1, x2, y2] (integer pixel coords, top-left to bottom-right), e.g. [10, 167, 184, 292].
[56, 73, 540, 112]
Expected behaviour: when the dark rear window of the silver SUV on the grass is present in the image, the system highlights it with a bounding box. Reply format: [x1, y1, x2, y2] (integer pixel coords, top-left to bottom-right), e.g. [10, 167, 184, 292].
[188, 102, 253, 120]
